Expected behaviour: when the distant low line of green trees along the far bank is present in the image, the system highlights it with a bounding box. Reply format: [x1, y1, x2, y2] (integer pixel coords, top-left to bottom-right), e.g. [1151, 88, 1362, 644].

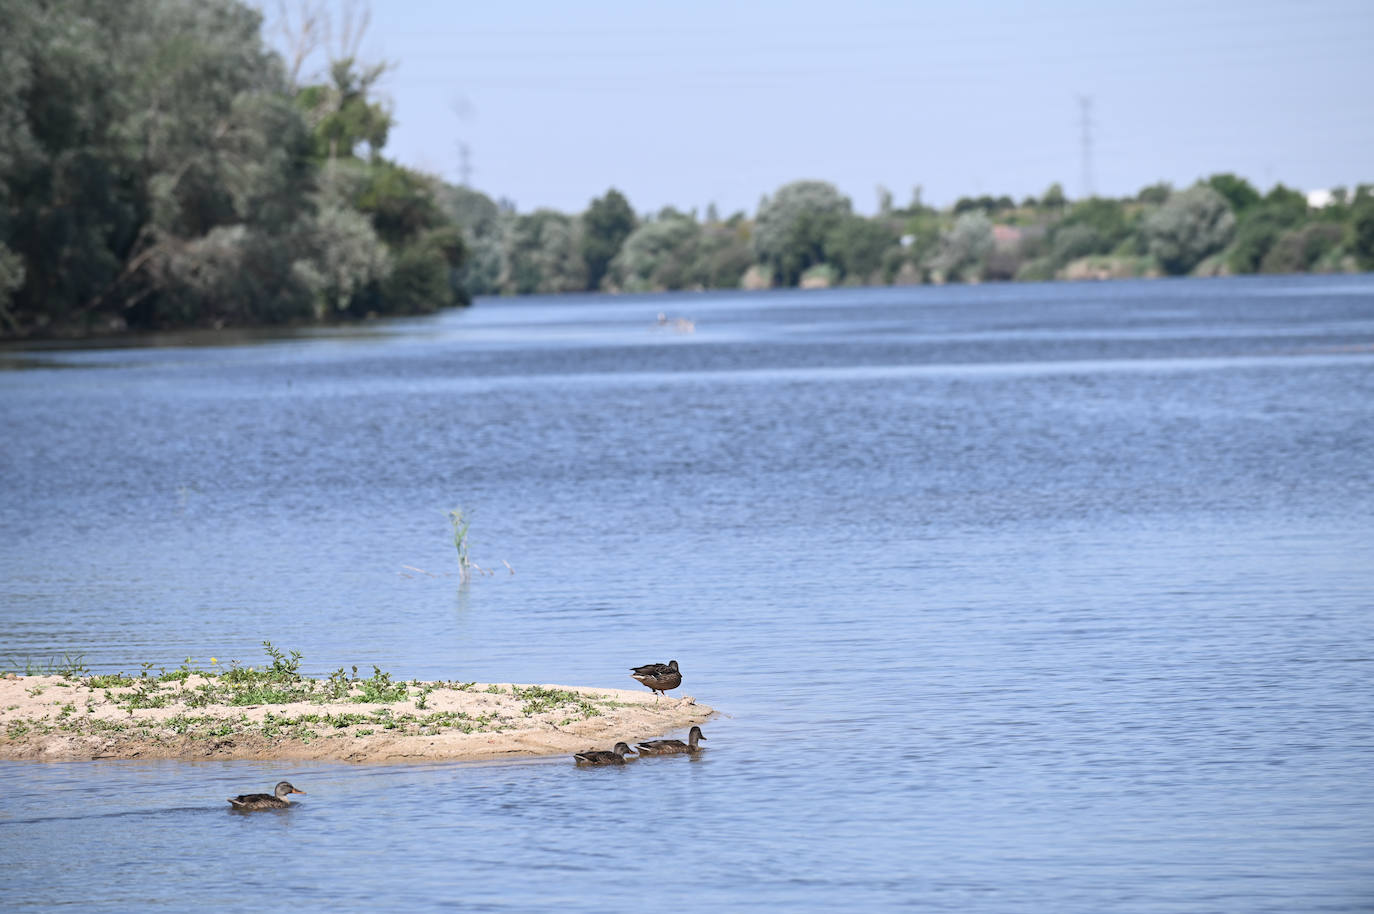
[452, 175, 1374, 294]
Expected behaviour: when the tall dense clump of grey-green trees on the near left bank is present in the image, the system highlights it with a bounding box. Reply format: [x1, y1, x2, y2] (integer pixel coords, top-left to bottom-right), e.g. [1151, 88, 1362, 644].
[0, 0, 466, 335]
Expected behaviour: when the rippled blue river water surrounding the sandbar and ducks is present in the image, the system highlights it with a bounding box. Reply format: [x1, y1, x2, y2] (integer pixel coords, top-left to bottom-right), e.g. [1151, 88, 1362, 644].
[0, 276, 1374, 914]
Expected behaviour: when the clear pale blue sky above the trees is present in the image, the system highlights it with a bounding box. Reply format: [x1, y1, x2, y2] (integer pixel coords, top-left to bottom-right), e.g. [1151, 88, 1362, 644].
[259, 0, 1374, 216]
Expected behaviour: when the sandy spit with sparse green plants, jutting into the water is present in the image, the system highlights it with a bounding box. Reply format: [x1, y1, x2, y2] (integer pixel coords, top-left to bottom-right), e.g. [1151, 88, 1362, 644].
[0, 673, 713, 761]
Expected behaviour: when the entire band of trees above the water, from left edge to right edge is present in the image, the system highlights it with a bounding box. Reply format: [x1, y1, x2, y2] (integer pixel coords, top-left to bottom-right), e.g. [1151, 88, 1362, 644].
[0, 0, 1374, 338]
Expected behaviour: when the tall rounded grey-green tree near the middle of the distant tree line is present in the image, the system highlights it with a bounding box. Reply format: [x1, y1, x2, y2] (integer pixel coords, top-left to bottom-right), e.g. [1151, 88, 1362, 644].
[753, 181, 851, 286]
